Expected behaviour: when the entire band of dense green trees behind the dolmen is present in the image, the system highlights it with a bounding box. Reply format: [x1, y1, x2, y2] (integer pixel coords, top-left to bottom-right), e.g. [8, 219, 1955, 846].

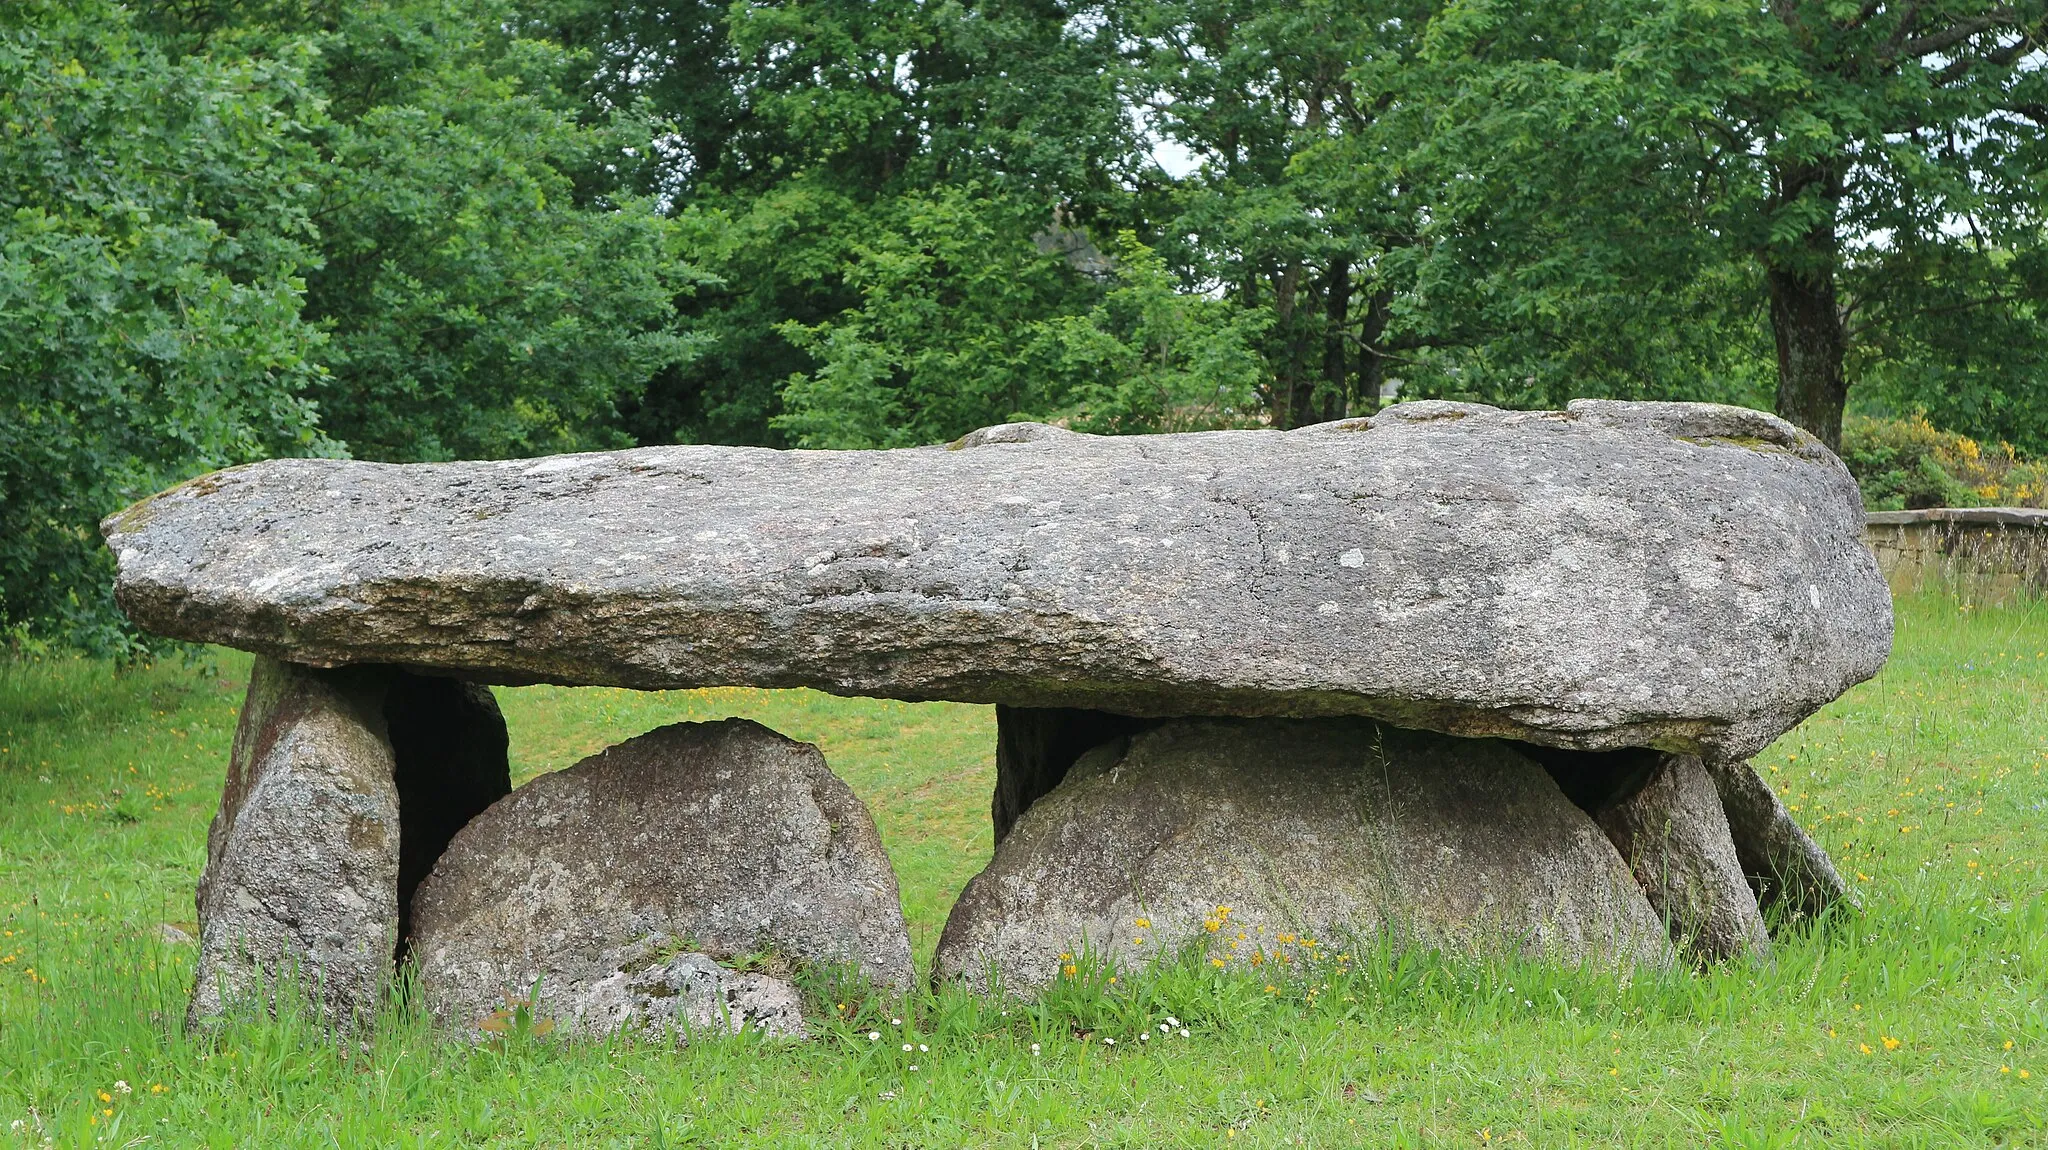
[0, 0, 2048, 647]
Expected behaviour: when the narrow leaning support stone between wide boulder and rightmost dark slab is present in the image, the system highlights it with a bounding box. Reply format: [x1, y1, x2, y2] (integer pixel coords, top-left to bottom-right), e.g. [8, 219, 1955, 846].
[1595, 755, 1769, 962]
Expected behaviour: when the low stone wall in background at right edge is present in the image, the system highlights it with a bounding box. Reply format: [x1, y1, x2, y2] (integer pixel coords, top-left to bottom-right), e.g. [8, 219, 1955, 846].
[1864, 507, 2048, 602]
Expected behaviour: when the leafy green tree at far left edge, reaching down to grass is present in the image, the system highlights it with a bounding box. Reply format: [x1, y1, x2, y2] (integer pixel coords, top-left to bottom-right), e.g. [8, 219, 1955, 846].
[0, 0, 334, 651]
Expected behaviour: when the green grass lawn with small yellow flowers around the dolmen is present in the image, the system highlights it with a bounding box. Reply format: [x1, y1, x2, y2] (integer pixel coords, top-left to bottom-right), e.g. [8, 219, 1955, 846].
[0, 598, 2048, 1146]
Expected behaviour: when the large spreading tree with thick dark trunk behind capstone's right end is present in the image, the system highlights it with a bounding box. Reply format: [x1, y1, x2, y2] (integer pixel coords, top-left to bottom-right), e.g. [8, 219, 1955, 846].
[1430, 0, 2048, 444]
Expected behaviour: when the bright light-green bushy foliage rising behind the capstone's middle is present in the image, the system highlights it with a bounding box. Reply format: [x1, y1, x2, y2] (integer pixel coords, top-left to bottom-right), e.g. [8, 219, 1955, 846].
[774, 203, 1264, 448]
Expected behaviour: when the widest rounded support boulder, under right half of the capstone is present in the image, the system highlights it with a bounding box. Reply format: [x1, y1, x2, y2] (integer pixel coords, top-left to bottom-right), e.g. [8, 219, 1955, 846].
[936, 720, 1671, 992]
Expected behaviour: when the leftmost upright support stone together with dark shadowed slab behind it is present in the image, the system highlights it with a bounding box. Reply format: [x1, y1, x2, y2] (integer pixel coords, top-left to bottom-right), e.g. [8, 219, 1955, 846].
[186, 659, 510, 1027]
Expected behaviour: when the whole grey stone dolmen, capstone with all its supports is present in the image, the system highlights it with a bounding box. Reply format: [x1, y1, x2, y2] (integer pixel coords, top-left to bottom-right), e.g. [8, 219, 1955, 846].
[102, 401, 1892, 1037]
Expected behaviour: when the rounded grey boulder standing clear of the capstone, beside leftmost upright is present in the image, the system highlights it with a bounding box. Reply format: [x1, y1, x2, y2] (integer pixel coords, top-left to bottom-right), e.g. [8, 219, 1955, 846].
[412, 718, 911, 1035]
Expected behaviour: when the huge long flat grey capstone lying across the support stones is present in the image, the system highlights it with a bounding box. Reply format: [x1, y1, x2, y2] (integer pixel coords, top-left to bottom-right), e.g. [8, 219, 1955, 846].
[104, 401, 1890, 757]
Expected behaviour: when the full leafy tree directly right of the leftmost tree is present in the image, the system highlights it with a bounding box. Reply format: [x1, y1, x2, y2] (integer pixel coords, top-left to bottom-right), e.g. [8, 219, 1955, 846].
[284, 0, 700, 458]
